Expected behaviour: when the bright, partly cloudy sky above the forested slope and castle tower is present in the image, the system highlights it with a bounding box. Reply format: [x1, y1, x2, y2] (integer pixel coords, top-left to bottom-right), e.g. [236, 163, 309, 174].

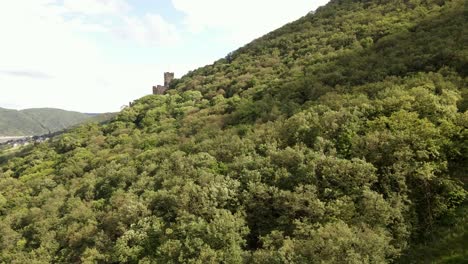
[0, 0, 328, 113]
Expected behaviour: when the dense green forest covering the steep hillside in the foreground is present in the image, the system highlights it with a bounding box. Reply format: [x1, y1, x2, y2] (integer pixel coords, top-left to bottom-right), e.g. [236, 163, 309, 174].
[0, 0, 468, 263]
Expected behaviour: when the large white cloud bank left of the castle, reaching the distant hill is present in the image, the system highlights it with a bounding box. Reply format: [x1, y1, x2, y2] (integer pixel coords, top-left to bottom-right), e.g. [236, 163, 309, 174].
[0, 0, 144, 112]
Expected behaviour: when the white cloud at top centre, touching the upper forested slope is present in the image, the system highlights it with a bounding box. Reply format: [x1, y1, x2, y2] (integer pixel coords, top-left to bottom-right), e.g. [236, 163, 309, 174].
[172, 0, 328, 45]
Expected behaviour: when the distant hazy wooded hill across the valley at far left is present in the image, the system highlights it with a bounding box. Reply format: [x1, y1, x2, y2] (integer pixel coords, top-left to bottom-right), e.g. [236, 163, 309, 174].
[0, 108, 92, 136]
